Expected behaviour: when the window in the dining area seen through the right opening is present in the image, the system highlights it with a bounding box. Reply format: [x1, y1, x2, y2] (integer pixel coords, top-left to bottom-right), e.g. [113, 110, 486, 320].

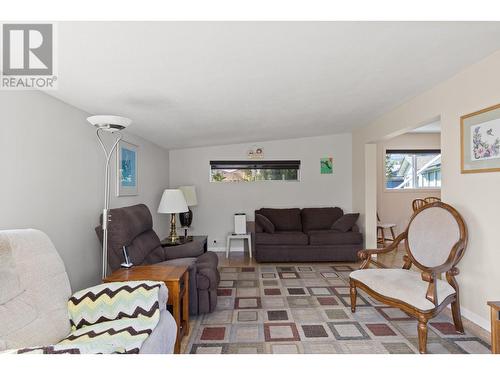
[384, 150, 441, 190]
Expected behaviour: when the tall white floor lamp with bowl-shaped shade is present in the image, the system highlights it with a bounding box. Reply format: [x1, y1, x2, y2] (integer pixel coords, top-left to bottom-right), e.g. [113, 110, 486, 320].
[87, 115, 132, 279]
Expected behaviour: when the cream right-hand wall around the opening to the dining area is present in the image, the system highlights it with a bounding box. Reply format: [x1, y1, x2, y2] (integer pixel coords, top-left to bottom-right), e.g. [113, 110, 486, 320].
[353, 48, 500, 330]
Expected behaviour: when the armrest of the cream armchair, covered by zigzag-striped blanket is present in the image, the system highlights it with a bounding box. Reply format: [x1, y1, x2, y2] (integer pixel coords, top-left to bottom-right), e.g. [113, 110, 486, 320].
[68, 280, 168, 330]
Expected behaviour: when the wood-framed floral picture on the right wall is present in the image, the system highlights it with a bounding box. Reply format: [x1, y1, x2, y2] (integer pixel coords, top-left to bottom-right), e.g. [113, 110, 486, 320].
[460, 104, 500, 173]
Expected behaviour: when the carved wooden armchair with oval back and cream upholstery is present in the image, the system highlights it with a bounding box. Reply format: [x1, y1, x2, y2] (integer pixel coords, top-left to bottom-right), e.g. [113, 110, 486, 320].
[349, 202, 467, 353]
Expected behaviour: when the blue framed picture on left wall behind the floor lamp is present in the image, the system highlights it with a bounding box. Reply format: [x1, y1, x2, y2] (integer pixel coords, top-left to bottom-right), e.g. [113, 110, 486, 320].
[116, 141, 138, 197]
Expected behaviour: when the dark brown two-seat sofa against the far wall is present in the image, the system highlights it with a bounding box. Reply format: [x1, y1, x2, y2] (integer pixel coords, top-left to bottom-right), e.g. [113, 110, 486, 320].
[255, 207, 363, 262]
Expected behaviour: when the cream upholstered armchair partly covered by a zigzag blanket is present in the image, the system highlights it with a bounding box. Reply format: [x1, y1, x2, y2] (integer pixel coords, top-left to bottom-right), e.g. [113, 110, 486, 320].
[0, 229, 177, 353]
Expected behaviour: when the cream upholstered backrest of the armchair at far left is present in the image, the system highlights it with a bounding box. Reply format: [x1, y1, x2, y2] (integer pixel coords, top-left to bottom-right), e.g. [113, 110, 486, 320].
[0, 229, 71, 350]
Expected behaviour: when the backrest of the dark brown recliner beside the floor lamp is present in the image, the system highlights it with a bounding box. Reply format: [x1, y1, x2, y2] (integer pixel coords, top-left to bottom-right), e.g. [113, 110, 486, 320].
[96, 204, 165, 271]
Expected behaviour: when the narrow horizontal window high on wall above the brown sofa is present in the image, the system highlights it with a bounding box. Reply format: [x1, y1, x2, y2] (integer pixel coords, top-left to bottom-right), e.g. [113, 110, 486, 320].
[210, 160, 300, 182]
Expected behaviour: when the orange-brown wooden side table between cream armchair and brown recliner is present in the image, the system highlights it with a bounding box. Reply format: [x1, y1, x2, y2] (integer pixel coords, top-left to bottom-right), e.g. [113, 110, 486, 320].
[103, 265, 189, 354]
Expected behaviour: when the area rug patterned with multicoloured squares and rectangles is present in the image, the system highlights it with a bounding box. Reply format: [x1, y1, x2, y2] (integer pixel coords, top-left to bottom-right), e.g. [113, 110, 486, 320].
[185, 264, 490, 354]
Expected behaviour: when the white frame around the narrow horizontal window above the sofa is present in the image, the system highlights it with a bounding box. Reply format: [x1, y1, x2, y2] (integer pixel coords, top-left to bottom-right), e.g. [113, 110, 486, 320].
[208, 160, 302, 183]
